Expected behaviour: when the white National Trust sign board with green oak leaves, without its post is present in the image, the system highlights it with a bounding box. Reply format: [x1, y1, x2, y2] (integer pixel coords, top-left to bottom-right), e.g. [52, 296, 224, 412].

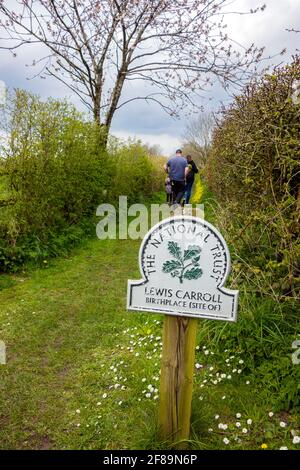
[127, 216, 238, 321]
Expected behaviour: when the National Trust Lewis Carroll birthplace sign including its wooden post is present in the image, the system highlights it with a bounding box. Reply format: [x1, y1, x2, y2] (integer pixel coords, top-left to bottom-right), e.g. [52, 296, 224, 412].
[127, 216, 238, 448]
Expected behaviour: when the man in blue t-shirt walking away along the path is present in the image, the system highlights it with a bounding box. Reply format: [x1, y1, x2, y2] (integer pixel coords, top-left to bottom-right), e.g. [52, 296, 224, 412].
[164, 149, 189, 204]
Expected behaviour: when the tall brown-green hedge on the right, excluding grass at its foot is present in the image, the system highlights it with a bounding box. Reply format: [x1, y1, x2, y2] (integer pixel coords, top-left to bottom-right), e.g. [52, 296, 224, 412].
[204, 57, 300, 297]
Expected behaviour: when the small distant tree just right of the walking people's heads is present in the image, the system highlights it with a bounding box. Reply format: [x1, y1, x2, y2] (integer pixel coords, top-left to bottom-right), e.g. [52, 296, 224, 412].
[183, 112, 216, 167]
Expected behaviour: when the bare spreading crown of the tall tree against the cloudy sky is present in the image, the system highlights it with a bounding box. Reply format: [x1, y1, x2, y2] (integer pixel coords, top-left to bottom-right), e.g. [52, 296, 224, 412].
[0, 0, 265, 141]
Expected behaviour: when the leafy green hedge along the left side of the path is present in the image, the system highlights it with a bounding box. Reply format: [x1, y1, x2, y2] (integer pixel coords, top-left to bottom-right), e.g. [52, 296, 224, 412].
[0, 90, 162, 272]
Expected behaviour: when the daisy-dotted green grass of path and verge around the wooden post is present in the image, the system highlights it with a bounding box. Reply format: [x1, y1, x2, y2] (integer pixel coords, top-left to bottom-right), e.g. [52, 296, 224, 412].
[0, 183, 300, 449]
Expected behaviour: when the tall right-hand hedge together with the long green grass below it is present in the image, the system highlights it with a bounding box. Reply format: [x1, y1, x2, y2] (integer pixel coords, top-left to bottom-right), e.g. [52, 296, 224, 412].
[202, 57, 300, 410]
